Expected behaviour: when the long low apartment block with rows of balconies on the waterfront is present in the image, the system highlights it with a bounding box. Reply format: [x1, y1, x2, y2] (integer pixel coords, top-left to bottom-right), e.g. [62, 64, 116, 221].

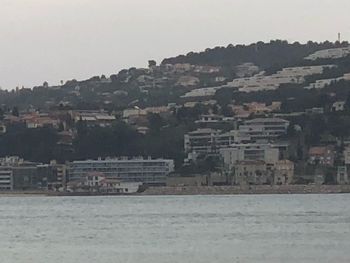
[68, 158, 174, 185]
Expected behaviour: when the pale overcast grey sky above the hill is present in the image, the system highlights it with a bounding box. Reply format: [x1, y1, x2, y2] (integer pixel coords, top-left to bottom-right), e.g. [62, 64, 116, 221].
[0, 0, 350, 89]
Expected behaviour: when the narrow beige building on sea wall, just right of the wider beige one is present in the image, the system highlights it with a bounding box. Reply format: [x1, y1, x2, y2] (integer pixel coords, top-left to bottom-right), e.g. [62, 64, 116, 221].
[274, 160, 294, 185]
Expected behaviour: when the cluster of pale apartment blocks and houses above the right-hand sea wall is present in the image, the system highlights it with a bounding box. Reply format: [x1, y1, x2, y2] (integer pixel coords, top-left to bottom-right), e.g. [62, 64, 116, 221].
[182, 116, 350, 185]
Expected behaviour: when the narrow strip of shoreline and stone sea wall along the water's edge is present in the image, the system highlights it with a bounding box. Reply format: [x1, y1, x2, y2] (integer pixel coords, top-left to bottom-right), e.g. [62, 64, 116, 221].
[0, 185, 350, 198]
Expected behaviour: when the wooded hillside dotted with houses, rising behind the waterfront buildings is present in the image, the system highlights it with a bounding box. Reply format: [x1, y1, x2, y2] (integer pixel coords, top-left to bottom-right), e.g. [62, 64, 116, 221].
[0, 41, 350, 173]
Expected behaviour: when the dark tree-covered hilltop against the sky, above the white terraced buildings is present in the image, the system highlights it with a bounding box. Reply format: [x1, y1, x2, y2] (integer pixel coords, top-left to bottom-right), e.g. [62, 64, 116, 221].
[162, 40, 349, 69]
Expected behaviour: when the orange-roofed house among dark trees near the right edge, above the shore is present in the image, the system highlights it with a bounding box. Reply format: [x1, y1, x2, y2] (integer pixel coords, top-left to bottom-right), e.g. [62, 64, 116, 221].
[308, 145, 335, 166]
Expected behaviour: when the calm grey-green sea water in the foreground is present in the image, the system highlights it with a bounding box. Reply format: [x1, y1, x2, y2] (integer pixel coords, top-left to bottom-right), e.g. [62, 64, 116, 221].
[0, 195, 350, 263]
